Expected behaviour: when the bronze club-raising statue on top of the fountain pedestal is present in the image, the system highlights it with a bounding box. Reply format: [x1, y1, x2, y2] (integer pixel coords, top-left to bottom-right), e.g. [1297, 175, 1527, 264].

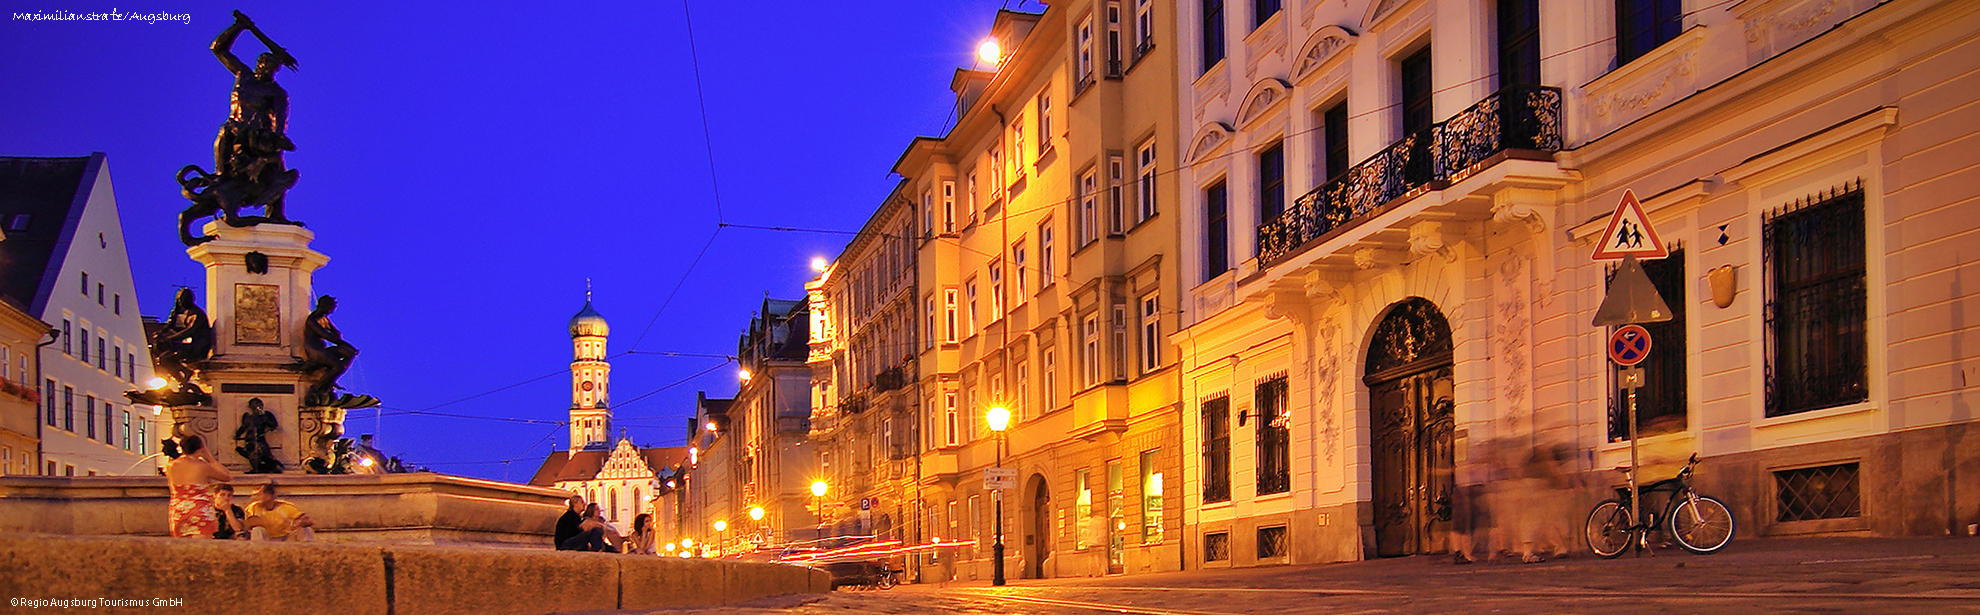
[178, 10, 299, 245]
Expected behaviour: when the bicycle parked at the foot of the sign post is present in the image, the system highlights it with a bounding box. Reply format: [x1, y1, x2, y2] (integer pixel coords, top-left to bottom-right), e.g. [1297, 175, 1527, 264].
[1586, 453, 1733, 560]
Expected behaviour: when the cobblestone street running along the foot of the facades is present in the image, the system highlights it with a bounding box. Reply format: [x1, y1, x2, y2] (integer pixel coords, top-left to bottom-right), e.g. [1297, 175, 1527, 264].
[617, 538, 1980, 615]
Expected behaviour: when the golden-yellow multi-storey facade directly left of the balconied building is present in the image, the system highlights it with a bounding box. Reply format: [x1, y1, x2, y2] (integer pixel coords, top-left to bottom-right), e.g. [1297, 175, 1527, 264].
[895, 2, 1182, 581]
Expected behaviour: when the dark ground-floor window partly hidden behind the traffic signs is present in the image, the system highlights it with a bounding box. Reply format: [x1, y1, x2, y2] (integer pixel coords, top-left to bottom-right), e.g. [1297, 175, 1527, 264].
[1608, 249, 1689, 443]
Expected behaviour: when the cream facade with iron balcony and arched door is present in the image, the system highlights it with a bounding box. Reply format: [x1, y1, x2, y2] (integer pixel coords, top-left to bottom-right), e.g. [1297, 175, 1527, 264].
[1170, 0, 1980, 568]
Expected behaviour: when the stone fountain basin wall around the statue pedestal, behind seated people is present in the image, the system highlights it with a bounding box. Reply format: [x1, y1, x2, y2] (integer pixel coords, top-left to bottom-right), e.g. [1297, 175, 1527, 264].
[0, 473, 568, 550]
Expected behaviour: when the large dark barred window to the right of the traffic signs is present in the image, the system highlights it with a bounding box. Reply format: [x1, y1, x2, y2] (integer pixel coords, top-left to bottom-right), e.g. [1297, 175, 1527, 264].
[1762, 184, 1869, 417]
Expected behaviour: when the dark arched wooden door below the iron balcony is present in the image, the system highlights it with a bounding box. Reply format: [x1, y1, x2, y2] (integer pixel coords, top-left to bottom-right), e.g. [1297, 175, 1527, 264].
[1362, 297, 1457, 558]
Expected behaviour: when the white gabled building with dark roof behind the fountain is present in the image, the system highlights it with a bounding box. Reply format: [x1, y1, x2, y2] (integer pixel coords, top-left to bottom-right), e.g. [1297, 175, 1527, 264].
[0, 152, 170, 477]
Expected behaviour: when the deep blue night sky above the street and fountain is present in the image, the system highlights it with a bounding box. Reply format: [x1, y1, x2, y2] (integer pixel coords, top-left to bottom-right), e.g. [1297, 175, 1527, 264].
[0, 0, 1041, 481]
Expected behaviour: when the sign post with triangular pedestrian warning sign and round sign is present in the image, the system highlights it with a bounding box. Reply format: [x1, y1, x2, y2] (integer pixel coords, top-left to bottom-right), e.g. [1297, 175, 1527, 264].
[1590, 190, 1671, 556]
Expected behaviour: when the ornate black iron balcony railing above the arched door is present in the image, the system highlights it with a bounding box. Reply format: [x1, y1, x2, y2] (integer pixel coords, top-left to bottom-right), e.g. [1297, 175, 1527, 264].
[1257, 85, 1560, 267]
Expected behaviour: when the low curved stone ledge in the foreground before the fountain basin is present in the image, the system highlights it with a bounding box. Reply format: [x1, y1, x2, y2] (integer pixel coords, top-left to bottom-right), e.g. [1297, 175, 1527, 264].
[0, 534, 832, 615]
